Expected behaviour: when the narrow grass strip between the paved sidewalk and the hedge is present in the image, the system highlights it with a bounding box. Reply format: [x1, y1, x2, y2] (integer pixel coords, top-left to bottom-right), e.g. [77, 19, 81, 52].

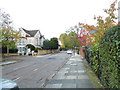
[83, 59, 104, 90]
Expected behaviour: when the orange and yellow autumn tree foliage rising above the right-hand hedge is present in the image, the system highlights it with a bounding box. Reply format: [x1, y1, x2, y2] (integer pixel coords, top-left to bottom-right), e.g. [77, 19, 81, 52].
[80, 1, 117, 45]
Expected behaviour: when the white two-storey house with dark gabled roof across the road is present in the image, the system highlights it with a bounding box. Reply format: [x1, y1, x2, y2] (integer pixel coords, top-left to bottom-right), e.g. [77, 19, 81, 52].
[17, 28, 45, 53]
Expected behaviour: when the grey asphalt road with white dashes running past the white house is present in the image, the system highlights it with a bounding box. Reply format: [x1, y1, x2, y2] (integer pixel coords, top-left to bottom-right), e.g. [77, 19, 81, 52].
[2, 52, 70, 88]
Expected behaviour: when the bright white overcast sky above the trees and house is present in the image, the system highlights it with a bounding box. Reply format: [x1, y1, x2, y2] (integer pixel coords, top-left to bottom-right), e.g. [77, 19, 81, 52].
[0, 0, 118, 39]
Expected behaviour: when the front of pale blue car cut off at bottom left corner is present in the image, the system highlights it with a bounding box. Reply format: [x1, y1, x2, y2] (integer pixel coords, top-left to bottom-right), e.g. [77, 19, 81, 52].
[0, 78, 19, 90]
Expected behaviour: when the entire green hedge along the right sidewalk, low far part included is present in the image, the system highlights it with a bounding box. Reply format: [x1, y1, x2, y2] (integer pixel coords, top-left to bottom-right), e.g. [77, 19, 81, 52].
[85, 25, 120, 88]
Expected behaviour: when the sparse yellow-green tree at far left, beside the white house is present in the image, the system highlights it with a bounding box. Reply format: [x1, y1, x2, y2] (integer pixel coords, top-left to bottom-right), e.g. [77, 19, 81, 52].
[0, 9, 19, 53]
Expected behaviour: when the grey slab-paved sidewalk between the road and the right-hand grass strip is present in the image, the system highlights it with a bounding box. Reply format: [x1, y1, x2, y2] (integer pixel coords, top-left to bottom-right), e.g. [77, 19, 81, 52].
[44, 55, 94, 88]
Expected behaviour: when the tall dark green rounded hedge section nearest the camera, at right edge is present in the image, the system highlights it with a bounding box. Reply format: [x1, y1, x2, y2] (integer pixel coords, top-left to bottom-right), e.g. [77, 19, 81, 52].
[99, 25, 120, 88]
